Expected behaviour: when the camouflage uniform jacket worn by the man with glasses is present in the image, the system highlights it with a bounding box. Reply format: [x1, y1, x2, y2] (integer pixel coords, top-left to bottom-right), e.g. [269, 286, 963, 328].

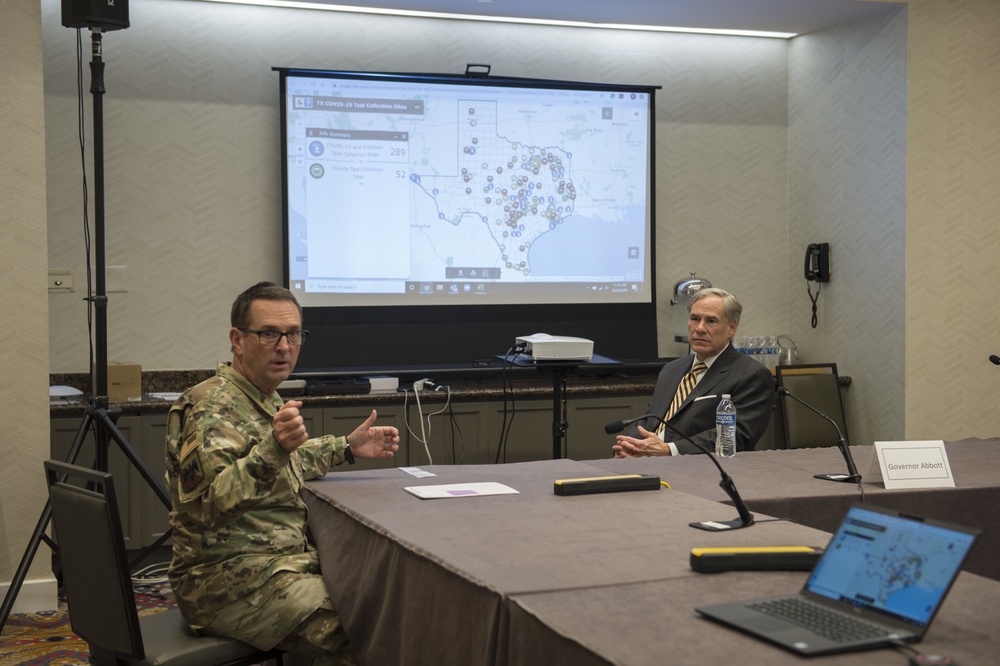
[166, 363, 347, 629]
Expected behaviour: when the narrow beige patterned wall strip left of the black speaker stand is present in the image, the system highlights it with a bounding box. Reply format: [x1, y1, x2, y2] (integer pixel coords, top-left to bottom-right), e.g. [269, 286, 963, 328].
[0, 2, 49, 580]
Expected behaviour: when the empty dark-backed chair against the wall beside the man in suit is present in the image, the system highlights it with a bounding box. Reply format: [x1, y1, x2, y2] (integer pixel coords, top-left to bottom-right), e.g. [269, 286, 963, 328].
[774, 363, 850, 449]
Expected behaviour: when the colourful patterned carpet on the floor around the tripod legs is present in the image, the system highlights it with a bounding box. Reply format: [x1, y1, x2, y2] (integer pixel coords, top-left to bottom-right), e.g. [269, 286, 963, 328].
[0, 585, 174, 666]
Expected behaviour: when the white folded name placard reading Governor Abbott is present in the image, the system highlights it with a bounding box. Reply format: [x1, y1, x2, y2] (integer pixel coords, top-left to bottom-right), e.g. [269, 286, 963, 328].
[864, 440, 955, 490]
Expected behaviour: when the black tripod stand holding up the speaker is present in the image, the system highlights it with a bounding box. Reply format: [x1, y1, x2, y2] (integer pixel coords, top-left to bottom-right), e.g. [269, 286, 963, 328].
[0, 26, 170, 629]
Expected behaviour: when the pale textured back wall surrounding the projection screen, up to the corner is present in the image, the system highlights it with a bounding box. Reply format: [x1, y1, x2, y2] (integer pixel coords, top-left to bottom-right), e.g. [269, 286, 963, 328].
[43, 0, 788, 372]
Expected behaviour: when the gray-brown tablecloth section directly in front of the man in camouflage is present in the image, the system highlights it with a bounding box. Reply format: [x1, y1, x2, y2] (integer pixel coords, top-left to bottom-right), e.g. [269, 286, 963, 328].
[303, 460, 829, 665]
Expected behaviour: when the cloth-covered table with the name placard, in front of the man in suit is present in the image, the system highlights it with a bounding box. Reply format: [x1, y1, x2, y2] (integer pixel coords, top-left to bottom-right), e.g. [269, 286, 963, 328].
[587, 438, 1000, 580]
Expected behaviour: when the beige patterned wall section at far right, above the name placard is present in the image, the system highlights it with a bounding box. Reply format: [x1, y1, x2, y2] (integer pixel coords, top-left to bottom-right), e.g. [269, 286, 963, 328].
[905, 0, 1000, 439]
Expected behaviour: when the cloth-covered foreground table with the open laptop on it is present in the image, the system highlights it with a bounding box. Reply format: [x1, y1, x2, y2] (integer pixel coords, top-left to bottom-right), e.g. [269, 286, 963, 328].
[303, 459, 1000, 666]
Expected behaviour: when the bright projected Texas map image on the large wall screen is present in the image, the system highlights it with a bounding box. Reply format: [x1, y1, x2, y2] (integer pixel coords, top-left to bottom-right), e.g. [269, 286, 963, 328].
[288, 78, 650, 294]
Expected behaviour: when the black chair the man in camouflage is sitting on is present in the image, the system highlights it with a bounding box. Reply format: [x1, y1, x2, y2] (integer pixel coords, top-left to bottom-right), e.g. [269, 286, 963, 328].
[44, 460, 282, 666]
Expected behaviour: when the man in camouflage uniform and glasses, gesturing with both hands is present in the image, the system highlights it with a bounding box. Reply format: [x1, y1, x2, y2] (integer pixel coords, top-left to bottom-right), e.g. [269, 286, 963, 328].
[166, 282, 399, 663]
